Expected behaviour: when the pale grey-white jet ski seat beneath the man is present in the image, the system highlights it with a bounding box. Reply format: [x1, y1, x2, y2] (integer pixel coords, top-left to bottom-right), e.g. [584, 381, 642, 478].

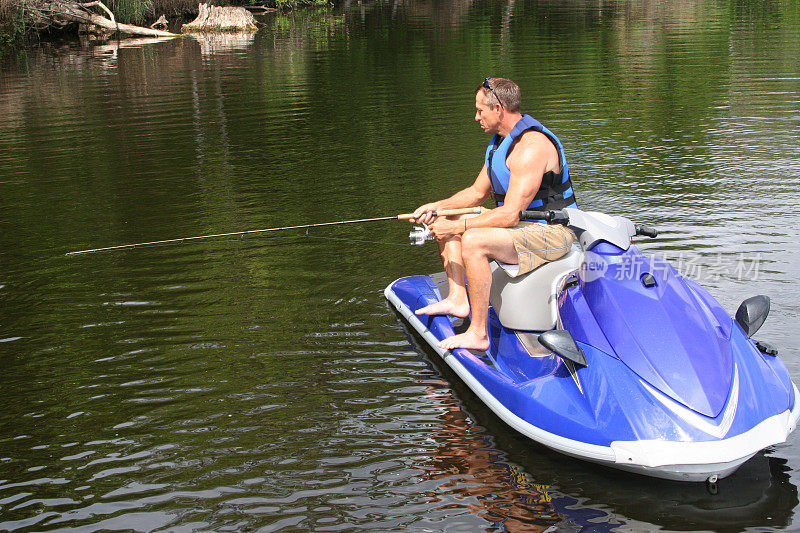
[489, 244, 583, 331]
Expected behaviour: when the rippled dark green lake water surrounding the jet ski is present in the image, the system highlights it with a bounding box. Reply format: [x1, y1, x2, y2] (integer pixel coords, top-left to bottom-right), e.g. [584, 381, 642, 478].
[0, 0, 800, 531]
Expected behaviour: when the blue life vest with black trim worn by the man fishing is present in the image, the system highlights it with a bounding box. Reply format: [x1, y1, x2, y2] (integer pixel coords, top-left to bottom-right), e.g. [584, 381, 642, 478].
[486, 115, 578, 211]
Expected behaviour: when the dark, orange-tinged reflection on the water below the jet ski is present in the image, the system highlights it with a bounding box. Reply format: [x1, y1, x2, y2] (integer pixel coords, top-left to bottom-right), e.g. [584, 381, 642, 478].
[398, 317, 799, 532]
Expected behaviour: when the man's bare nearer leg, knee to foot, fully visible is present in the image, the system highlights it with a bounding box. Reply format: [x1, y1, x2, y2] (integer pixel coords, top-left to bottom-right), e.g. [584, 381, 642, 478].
[438, 228, 519, 350]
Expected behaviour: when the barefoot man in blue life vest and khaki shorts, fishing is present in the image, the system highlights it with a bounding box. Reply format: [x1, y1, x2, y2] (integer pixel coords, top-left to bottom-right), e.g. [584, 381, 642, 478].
[414, 78, 577, 350]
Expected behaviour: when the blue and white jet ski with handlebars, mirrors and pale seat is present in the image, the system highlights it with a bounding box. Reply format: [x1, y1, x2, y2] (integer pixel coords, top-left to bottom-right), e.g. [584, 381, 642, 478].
[384, 208, 800, 483]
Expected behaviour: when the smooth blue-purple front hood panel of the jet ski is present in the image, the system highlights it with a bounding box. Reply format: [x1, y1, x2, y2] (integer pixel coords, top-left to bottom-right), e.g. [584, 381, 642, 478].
[584, 254, 733, 418]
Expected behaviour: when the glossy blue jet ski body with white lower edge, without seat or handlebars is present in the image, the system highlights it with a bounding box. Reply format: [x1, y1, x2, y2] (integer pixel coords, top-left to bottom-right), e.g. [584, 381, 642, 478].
[384, 264, 800, 481]
